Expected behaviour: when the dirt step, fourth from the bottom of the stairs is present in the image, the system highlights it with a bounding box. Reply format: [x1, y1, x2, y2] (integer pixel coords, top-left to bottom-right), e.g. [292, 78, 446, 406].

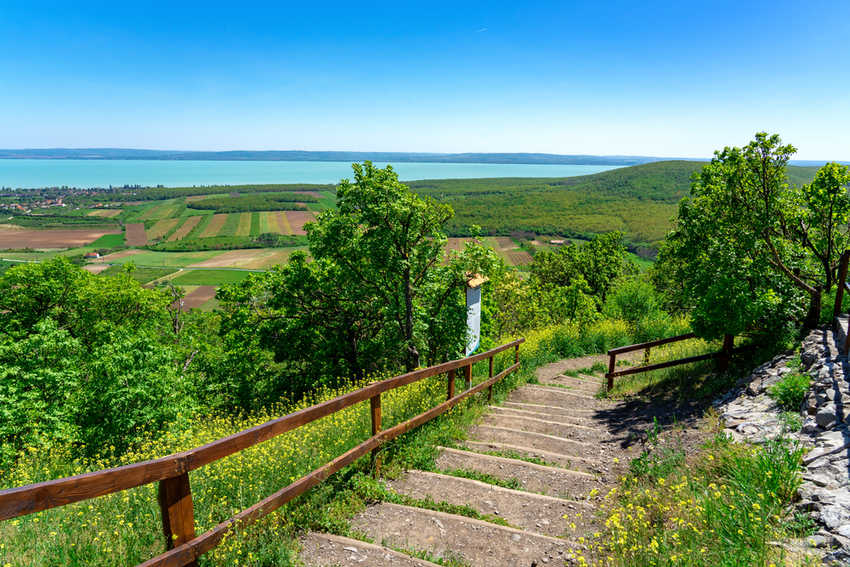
[437, 447, 601, 498]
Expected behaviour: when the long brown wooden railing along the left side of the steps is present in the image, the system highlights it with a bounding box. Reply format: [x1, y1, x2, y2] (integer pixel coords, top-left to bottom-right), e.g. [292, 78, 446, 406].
[0, 339, 525, 567]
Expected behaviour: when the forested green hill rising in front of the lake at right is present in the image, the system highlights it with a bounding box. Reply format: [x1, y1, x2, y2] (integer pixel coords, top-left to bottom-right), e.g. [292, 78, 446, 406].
[410, 161, 817, 247]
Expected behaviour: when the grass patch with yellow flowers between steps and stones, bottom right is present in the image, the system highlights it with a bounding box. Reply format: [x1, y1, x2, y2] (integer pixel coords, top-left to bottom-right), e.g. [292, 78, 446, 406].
[578, 434, 811, 567]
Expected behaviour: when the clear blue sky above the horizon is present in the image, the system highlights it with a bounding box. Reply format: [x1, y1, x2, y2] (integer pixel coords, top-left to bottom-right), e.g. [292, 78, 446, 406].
[0, 0, 850, 160]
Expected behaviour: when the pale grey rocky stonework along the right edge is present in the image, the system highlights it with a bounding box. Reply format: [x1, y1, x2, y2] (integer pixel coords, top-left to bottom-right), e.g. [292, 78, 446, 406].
[715, 326, 850, 565]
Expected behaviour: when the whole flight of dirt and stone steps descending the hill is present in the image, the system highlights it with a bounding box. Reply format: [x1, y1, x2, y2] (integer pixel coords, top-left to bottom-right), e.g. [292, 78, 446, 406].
[301, 359, 651, 567]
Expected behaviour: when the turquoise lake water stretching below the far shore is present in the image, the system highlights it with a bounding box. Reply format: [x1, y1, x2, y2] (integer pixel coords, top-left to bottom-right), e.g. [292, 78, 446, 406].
[0, 159, 618, 188]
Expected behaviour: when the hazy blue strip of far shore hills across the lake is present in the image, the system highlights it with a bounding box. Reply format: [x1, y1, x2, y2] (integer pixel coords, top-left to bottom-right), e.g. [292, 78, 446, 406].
[0, 148, 662, 165]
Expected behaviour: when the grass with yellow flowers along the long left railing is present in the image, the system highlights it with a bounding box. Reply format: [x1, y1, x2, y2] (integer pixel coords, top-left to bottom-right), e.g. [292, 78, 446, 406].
[0, 326, 555, 567]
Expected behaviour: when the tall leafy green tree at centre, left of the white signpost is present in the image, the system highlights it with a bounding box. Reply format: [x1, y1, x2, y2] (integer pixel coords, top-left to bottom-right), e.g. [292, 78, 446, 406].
[219, 162, 486, 400]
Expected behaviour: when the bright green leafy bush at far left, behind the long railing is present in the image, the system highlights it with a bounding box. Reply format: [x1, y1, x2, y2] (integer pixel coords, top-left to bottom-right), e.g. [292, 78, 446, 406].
[0, 257, 191, 462]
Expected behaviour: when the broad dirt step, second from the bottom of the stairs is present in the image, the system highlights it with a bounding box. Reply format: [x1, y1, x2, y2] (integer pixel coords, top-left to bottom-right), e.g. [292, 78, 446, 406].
[344, 502, 570, 567]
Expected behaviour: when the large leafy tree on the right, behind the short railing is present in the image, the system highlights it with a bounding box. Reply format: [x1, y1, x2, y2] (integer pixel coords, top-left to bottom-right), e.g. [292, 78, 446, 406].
[656, 133, 814, 340]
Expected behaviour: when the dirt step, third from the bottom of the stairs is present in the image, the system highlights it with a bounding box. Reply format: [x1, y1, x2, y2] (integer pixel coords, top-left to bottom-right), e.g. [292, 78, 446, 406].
[386, 470, 590, 537]
